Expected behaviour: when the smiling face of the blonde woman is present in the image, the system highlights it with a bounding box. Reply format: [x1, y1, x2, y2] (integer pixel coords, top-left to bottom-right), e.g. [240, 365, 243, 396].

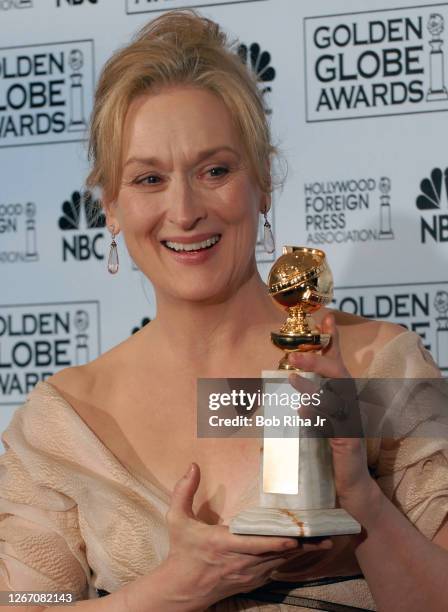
[108, 87, 268, 302]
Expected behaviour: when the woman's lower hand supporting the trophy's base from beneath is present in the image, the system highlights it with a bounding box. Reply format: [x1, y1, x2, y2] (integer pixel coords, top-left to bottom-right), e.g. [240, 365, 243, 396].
[163, 463, 332, 610]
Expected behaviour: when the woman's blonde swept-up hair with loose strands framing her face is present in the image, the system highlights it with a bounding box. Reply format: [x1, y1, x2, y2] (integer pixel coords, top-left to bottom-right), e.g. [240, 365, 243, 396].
[86, 10, 278, 200]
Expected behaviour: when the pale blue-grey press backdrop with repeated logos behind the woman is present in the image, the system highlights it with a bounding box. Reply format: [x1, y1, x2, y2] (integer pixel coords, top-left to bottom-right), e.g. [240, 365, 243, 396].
[0, 0, 448, 430]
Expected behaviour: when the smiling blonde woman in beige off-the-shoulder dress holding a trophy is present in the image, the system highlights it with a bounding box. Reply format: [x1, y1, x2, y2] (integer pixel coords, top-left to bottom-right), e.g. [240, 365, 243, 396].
[0, 11, 448, 612]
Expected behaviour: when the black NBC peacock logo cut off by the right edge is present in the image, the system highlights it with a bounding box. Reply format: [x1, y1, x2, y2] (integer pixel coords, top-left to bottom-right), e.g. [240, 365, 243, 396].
[415, 167, 448, 244]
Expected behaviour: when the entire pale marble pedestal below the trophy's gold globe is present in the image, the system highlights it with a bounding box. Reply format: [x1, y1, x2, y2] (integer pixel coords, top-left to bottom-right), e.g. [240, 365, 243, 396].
[229, 370, 361, 538]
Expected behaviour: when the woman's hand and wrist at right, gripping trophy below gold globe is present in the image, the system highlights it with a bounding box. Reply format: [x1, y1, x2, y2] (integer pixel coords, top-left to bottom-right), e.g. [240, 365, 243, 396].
[289, 314, 382, 524]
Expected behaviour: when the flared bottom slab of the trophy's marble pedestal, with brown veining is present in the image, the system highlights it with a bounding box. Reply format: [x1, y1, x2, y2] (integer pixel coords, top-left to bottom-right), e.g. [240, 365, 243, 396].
[229, 507, 361, 538]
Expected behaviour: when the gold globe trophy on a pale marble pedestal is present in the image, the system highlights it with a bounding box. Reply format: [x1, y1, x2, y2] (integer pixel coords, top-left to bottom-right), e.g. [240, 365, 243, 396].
[229, 246, 361, 537]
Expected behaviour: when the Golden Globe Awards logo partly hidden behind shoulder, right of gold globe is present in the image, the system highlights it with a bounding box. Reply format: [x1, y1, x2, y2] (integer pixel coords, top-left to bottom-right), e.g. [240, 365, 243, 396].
[333, 282, 448, 375]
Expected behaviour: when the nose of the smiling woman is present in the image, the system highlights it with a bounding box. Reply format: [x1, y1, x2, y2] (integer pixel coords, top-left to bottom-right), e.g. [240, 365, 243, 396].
[167, 180, 207, 230]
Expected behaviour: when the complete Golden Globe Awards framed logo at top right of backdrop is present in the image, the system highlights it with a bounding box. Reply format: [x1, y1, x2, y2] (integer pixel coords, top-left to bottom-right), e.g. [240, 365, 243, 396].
[304, 4, 448, 122]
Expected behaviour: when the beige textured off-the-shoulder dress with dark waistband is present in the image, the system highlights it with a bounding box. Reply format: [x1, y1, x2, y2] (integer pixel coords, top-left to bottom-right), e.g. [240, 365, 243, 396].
[0, 332, 448, 612]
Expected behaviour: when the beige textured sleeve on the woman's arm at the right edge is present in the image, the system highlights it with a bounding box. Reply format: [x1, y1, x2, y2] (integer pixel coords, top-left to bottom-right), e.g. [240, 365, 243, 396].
[367, 332, 448, 539]
